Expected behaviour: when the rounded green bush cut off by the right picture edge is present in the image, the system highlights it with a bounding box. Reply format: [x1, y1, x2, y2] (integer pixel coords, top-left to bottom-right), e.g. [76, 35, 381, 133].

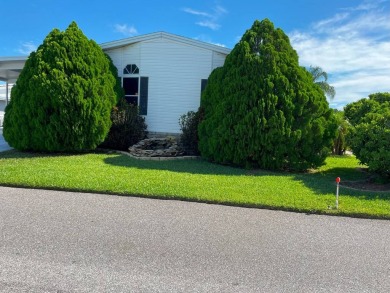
[345, 93, 390, 179]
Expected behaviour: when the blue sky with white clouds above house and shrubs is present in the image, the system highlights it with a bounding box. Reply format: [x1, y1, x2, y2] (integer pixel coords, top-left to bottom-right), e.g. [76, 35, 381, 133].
[0, 0, 390, 108]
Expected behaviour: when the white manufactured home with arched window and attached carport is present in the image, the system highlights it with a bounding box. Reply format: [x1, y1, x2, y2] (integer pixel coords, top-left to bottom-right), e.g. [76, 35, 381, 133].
[0, 32, 230, 133]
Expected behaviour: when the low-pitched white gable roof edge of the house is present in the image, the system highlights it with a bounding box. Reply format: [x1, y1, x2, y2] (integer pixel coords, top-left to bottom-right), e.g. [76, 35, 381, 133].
[100, 32, 231, 55]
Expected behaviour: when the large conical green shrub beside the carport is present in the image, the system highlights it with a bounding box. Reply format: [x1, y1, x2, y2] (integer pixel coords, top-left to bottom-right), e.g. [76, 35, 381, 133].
[4, 22, 117, 152]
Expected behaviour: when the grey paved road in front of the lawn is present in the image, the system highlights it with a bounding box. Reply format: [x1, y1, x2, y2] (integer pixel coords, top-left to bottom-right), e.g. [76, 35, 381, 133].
[0, 187, 390, 292]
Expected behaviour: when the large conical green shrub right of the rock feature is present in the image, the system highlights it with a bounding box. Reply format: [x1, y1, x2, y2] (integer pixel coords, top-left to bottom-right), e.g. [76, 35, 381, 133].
[199, 19, 336, 170]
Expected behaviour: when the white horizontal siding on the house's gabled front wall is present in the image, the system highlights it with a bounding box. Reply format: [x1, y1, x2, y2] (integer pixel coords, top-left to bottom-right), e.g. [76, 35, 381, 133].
[106, 38, 229, 133]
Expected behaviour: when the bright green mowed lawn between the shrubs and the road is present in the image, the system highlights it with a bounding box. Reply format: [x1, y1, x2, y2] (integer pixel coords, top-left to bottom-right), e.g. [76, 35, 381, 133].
[0, 150, 390, 219]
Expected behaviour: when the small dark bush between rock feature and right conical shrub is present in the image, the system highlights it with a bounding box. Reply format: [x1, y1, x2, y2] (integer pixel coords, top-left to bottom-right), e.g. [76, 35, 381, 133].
[179, 111, 199, 155]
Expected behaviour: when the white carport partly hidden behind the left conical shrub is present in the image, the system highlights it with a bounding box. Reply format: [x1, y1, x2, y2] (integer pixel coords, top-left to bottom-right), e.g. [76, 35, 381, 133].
[0, 56, 27, 105]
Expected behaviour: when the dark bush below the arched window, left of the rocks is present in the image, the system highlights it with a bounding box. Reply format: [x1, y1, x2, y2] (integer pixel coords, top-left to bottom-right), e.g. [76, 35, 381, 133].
[100, 99, 147, 151]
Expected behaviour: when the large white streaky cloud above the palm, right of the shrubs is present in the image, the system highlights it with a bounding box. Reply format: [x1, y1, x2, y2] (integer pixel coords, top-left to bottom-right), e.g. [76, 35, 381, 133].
[290, 0, 390, 108]
